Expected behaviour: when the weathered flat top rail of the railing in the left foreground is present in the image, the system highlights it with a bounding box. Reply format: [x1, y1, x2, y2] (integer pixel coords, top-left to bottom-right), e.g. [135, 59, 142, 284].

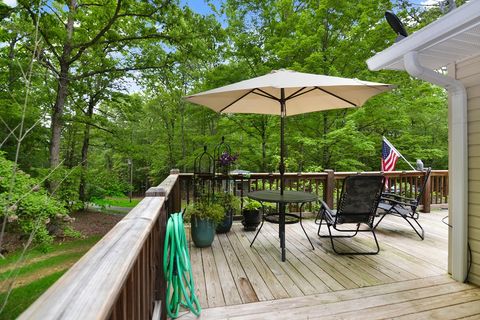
[19, 175, 178, 319]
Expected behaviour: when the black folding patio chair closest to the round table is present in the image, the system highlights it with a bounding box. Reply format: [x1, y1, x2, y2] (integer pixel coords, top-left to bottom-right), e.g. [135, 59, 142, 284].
[317, 175, 385, 255]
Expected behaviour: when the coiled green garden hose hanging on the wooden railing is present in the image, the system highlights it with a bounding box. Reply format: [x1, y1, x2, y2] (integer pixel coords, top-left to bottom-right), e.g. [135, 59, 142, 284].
[163, 213, 201, 319]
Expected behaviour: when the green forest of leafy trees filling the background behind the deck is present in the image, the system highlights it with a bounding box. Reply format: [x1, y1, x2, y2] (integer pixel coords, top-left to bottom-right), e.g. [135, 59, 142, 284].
[0, 0, 465, 244]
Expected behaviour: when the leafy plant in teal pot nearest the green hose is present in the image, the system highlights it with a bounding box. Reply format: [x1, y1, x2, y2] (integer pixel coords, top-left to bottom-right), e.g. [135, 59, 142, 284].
[185, 198, 224, 248]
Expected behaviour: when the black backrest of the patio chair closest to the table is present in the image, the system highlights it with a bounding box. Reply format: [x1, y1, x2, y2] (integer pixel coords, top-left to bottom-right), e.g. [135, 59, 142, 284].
[336, 175, 385, 225]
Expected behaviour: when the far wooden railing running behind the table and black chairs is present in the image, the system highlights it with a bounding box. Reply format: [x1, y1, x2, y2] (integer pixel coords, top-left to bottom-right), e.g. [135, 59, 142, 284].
[180, 170, 448, 212]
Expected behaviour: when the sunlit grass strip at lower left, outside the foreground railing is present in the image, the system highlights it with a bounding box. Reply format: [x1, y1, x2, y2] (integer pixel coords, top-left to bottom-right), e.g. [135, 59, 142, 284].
[0, 236, 101, 320]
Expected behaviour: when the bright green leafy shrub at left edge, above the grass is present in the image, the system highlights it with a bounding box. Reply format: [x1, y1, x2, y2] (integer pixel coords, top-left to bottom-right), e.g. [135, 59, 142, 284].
[0, 153, 71, 245]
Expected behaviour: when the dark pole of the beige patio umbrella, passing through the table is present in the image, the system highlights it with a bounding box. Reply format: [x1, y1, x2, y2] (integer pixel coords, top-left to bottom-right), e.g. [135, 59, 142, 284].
[278, 88, 286, 261]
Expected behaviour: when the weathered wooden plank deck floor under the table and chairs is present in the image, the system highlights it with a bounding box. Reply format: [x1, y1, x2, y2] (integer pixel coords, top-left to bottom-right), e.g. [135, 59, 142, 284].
[182, 211, 480, 320]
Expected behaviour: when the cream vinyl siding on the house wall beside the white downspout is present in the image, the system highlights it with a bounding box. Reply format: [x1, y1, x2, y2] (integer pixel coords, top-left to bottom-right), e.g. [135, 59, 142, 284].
[455, 55, 480, 285]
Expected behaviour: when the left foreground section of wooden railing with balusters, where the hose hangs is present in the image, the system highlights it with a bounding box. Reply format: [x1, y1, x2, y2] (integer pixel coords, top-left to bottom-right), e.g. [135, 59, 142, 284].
[20, 170, 180, 320]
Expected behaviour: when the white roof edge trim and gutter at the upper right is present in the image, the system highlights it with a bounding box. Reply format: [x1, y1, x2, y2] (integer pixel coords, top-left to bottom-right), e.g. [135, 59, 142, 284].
[367, 0, 480, 70]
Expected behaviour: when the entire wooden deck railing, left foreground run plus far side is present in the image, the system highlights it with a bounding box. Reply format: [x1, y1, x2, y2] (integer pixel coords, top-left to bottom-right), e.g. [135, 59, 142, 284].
[15, 170, 448, 320]
